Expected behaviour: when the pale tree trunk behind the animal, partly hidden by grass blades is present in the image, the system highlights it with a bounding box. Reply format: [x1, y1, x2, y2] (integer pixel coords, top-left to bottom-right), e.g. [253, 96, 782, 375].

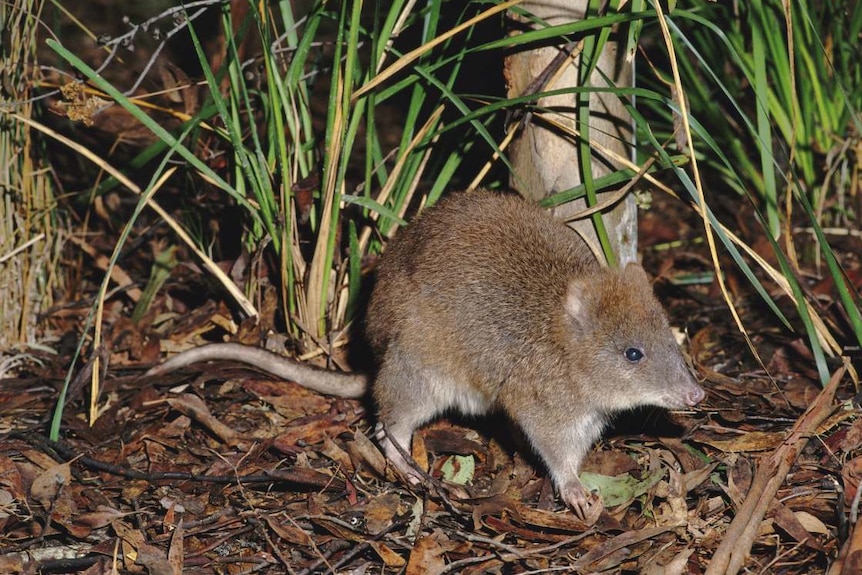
[506, 0, 637, 265]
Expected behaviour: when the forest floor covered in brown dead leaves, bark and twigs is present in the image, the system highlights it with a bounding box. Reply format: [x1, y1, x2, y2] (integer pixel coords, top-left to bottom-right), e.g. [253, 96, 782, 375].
[0, 191, 862, 574]
